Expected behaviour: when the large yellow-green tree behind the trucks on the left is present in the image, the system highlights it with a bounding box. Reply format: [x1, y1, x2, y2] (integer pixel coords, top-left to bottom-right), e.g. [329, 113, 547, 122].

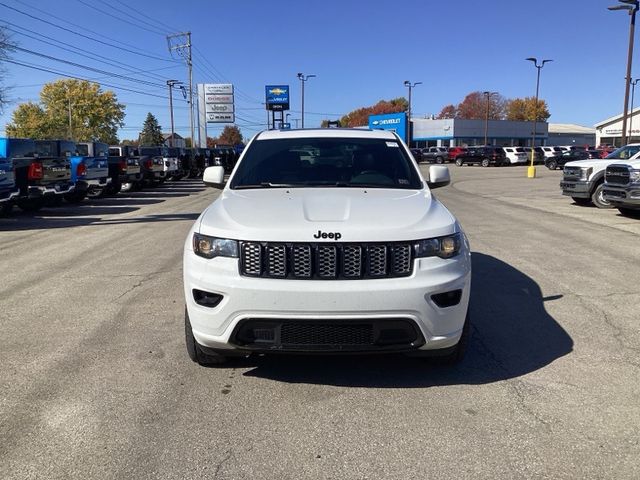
[7, 79, 125, 143]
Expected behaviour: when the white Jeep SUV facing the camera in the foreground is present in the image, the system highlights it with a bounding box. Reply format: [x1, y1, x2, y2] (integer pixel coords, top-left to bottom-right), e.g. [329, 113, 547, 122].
[184, 129, 471, 364]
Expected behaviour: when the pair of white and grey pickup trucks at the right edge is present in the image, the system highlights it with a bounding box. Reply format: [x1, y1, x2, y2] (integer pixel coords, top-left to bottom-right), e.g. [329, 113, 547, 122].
[560, 143, 640, 217]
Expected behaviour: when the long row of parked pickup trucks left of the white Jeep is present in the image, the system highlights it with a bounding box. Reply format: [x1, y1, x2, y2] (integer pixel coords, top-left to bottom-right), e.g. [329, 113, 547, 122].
[0, 138, 239, 215]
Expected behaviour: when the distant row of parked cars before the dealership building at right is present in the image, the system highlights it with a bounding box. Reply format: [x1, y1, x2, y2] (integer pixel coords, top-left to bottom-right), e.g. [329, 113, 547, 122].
[411, 145, 609, 170]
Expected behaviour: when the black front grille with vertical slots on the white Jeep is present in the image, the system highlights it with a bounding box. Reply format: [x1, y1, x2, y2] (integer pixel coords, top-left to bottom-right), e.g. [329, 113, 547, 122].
[240, 242, 413, 280]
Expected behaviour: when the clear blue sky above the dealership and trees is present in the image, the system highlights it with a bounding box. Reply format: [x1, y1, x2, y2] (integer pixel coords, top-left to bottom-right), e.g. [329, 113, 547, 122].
[0, 0, 640, 139]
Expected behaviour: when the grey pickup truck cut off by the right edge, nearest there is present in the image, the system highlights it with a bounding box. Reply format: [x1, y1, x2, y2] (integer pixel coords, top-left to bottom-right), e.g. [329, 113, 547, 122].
[602, 157, 640, 217]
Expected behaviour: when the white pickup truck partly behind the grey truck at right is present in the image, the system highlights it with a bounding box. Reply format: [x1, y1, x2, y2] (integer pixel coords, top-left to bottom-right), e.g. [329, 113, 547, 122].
[560, 143, 640, 208]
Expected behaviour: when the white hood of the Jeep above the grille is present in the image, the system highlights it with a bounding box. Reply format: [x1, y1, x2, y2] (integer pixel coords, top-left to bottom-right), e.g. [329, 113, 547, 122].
[199, 188, 458, 242]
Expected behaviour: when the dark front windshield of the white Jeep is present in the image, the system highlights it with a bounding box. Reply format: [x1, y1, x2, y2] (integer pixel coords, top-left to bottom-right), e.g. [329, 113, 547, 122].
[231, 138, 422, 189]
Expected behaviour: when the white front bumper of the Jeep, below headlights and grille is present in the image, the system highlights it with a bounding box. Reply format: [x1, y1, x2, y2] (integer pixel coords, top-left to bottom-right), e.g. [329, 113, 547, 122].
[183, 248, 471, 352]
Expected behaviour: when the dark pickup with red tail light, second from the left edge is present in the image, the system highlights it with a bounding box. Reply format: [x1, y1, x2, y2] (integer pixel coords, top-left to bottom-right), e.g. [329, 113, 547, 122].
[10, 138, 75, 211]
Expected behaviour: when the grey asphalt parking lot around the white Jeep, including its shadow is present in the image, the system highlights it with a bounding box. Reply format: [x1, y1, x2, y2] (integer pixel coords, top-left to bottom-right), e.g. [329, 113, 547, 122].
[0, 164, 640, 479]
